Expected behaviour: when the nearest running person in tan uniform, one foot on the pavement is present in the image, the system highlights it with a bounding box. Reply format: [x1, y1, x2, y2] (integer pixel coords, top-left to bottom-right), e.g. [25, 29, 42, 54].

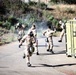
[19, 32, 36, 67]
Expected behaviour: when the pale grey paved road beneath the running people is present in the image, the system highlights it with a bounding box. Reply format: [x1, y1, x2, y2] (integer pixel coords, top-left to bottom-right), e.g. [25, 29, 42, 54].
[0, 37, 76, 75]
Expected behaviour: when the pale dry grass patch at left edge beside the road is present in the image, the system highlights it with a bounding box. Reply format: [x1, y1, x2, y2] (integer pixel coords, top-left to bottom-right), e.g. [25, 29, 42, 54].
[0, 28, 17, 46]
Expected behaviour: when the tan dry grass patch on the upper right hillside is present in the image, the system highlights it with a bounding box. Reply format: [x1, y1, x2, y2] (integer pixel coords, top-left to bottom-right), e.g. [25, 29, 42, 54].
[47, 4, 76, 19]
